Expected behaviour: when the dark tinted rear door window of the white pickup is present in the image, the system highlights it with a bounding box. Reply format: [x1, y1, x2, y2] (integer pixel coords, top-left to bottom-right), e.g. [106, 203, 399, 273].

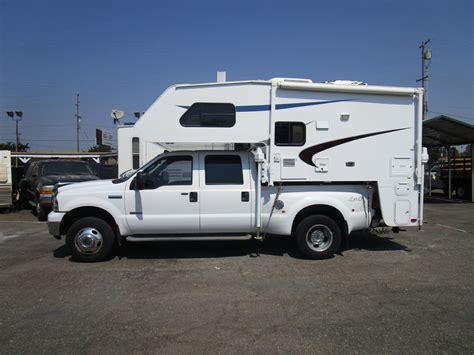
[204, 155, 244, 185]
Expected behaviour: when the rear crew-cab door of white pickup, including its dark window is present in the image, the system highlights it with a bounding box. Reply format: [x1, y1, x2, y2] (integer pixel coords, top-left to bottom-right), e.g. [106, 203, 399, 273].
[199, 152, 253, 233]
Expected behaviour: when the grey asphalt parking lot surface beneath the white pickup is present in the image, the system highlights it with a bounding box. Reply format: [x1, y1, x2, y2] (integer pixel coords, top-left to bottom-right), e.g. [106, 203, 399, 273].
[0, 201, 474, 354]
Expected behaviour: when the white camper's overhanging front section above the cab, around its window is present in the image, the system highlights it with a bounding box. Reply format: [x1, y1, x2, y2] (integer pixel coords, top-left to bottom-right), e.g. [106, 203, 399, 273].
[135, 83, 270, 143]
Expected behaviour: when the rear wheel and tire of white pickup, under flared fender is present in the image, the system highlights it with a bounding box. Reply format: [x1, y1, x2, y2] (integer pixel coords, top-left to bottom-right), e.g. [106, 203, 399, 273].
[295, 215, 341, 259]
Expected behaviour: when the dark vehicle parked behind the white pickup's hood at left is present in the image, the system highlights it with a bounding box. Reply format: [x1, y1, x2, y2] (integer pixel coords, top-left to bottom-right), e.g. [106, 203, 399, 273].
[20, 159, 99, 221]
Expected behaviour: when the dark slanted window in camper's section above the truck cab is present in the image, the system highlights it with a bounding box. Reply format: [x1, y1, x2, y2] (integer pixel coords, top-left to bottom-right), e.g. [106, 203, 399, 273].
[179, 102, 235, 127]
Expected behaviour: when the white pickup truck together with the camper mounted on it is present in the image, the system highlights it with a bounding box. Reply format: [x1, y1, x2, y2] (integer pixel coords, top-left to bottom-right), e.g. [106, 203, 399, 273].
[48, 78, 427, 261]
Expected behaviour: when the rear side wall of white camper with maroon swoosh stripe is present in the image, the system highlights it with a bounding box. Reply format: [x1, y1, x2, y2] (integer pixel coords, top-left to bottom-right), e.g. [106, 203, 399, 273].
[270, 90, 419, 226]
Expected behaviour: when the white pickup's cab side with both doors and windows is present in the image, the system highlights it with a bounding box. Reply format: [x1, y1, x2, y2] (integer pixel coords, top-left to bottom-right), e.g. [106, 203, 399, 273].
[124, 152, 254, 235]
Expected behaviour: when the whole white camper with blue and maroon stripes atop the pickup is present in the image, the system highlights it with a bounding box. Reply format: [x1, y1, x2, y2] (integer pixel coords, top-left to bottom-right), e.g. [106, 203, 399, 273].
[128, 78, 423, 226]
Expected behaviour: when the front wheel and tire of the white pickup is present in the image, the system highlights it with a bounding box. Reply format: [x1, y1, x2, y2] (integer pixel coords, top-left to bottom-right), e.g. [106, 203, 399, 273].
[66, 217, 115, 262]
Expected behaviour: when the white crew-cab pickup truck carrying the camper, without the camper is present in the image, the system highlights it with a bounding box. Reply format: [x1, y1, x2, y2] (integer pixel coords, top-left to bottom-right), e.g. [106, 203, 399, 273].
[48, 151, 376, 261]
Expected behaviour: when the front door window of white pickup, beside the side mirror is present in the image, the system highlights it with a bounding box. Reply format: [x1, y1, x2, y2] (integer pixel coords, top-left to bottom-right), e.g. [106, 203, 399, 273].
[144, 156, 193, 190]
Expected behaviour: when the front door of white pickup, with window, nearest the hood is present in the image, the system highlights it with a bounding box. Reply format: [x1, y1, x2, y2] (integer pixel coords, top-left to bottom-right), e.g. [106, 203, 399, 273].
[125, 152, 199, 235]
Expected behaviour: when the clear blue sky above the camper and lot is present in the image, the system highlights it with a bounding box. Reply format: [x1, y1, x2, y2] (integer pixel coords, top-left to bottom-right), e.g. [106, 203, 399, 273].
[0, 0, 474, 152]
